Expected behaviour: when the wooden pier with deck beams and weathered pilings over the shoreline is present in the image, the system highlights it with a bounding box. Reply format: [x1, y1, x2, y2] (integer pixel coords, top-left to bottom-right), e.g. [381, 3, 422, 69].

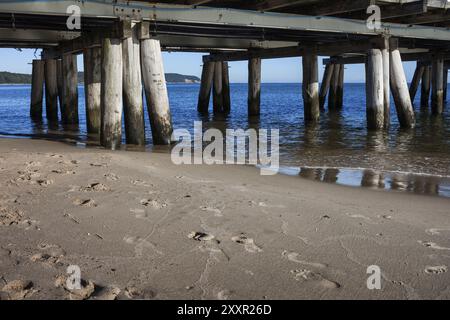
[0, 0, 450, 149]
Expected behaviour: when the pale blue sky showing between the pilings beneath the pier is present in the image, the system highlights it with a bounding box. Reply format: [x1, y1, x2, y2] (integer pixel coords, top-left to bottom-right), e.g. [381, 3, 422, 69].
[0, 49, 415, 83]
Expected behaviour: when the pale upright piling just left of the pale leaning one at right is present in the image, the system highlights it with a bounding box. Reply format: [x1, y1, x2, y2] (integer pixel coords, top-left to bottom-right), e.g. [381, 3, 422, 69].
[366, 49, 384, 130]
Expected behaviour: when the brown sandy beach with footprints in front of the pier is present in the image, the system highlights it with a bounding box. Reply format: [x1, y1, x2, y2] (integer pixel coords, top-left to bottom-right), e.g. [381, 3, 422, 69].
[0, 139, 450, 299]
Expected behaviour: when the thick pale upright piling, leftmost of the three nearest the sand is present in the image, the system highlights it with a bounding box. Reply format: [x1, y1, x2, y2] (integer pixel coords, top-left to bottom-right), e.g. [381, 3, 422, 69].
[100, 38, 123, 150]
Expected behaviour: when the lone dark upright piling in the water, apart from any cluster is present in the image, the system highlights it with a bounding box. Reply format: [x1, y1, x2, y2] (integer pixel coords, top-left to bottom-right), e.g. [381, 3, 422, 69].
[248, 58, 261, 116]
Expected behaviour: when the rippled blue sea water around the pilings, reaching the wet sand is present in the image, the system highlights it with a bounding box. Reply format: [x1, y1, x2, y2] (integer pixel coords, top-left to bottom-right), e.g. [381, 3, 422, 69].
[0, 83, 450, 197]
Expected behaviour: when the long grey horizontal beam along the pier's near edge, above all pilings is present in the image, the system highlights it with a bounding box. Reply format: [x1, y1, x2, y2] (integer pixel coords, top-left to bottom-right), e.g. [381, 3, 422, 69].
[0, 0, 450, 41]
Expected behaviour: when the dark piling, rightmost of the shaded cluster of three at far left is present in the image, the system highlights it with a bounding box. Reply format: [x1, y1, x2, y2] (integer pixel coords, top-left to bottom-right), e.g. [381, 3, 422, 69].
[62, 54, 78, 124]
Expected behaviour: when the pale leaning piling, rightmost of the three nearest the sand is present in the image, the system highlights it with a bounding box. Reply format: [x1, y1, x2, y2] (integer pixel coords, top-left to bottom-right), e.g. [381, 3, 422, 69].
[141, 38, 173, 145]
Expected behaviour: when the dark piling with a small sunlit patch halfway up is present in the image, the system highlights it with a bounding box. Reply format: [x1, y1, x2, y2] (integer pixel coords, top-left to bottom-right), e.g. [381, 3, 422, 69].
[302, 53, 320, 123]
